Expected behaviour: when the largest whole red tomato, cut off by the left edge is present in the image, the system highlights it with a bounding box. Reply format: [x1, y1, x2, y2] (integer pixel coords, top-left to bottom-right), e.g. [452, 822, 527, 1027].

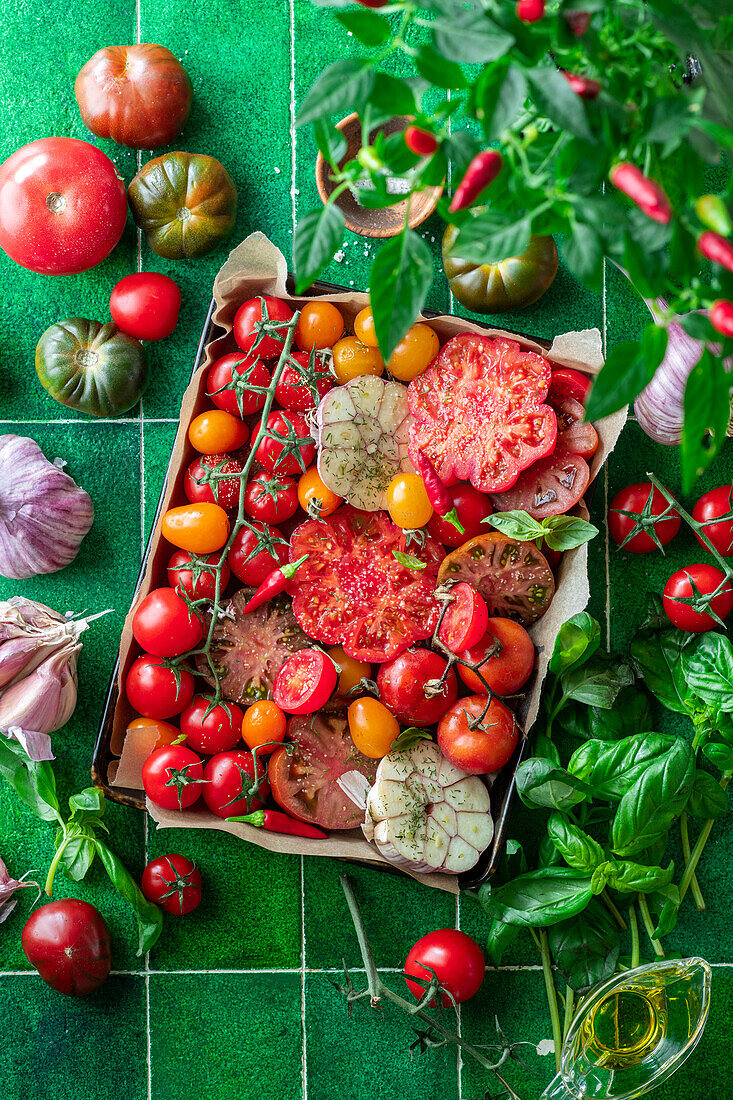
[0, 138, 128, 275]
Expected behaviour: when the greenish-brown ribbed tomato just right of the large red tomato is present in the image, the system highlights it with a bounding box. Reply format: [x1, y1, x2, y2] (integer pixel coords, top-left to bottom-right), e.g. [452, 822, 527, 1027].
[128, 153, 237, 260]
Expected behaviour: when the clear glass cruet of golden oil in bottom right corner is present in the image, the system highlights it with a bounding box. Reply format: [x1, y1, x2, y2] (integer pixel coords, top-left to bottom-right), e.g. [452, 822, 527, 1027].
[543, 958, 712, 1100]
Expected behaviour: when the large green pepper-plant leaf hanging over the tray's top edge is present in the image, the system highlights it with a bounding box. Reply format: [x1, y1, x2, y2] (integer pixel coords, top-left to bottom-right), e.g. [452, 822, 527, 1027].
[370, 229, 433, 363]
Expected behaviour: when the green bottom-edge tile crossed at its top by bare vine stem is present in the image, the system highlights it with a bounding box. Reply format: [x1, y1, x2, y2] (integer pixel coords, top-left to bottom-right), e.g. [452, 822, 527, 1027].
[303, 972, 458, 1100]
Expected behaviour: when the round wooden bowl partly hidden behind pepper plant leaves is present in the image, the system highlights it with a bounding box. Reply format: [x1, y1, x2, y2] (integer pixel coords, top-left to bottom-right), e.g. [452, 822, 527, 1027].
[316, 112, 442, 238]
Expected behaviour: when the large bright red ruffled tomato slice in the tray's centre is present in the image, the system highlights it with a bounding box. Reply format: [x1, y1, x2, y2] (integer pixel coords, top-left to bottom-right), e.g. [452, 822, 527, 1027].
[288, 505, 442, 661]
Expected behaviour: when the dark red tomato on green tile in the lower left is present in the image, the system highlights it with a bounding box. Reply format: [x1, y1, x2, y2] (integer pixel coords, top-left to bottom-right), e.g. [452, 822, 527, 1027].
[21, 898, 112, 997]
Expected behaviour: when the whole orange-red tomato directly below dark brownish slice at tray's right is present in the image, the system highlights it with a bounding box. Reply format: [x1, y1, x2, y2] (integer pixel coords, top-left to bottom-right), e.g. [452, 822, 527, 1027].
[458, 618, 535, 695]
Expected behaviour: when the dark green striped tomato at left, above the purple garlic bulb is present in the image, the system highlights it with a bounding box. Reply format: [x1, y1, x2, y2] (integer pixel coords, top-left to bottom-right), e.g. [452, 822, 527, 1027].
[35, 317, 149, 416]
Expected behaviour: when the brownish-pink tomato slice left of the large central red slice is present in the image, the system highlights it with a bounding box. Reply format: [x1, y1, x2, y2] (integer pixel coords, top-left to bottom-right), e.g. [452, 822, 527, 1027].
[196, 587, 313, 704]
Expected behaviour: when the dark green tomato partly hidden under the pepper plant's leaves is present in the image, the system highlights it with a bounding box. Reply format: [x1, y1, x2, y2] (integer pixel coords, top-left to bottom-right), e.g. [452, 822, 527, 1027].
[442, 226, 558, 314]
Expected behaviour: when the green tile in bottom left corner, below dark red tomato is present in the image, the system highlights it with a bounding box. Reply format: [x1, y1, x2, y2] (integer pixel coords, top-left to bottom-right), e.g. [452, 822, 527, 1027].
[0, 975, 147, 1100]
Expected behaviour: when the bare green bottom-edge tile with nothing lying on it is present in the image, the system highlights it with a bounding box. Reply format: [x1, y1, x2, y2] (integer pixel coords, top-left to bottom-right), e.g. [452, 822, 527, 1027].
[150, 972, 303, 1100]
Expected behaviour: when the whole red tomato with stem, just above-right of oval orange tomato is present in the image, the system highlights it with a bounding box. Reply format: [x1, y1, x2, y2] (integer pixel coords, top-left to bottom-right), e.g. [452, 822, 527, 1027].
[376, 648, 458, 726]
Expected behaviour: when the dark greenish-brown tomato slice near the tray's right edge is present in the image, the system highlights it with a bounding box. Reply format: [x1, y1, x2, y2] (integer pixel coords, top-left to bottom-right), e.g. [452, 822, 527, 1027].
[438, 534, 550, 626]
